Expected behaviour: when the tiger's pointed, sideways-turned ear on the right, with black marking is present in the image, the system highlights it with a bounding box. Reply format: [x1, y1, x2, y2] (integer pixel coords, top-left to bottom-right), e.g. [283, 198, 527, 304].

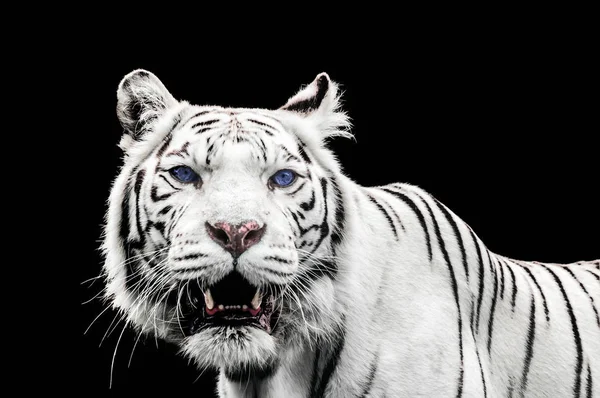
[279, 72, 350, 137]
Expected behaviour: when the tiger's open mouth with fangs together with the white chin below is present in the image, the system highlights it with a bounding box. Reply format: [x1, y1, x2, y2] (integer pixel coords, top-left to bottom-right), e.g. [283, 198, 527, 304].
[180, 272, 281, 378]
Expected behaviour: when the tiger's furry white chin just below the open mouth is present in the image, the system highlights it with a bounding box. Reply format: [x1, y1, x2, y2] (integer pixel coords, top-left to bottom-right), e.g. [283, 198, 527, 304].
[181, 326, 278, 380]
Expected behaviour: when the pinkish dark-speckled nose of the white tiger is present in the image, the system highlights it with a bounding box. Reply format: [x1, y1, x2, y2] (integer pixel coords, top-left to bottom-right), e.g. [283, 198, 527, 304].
[206, 221, 265, 257]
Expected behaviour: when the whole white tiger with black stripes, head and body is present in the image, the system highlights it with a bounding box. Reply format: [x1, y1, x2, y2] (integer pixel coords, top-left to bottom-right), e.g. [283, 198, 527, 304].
[104, 71, 600, 397]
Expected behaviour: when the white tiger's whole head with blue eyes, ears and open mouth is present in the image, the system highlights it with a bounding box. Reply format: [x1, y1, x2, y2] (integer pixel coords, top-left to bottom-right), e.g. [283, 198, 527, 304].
[103, 70, 349, 379]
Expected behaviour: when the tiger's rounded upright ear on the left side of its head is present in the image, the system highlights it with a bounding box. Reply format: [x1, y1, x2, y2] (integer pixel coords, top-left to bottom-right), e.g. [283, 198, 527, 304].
[117, 69, 178, 140]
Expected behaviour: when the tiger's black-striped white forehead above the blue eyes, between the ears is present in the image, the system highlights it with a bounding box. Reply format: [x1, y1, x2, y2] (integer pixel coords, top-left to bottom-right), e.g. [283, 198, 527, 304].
[159, 107, 298, 164]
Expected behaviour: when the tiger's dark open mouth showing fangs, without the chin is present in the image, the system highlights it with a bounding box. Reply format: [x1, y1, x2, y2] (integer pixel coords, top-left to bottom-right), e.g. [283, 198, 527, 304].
[182, 272, 278, 336]
